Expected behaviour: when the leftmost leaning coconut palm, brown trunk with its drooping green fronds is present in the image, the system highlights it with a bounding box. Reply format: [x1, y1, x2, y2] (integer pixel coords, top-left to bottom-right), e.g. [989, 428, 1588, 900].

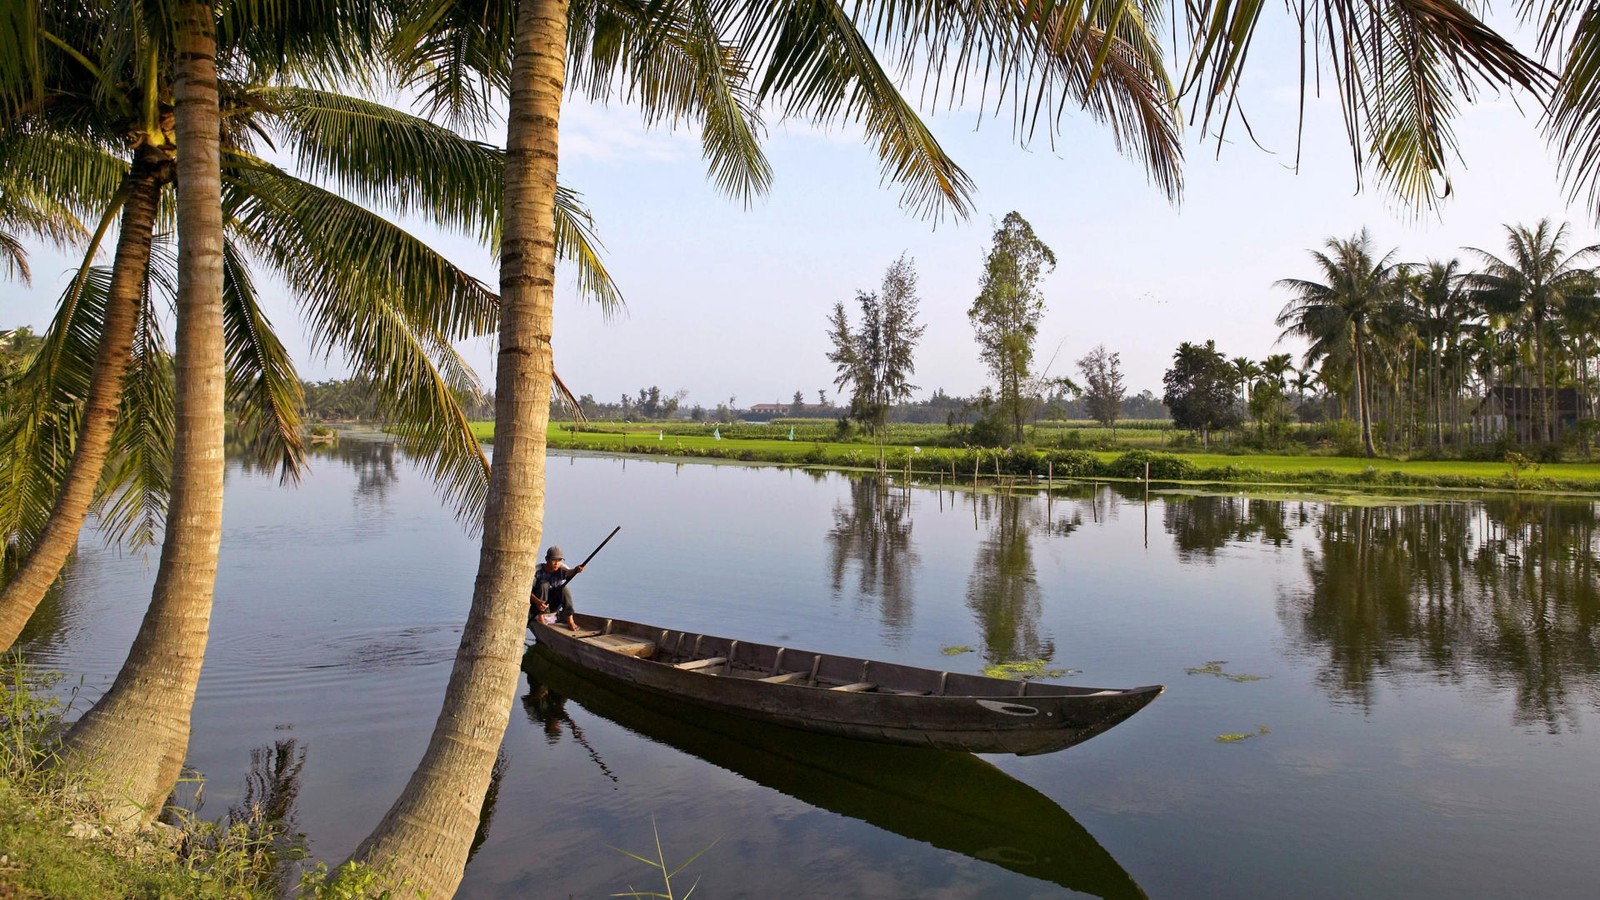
[0, 0, 616, 644]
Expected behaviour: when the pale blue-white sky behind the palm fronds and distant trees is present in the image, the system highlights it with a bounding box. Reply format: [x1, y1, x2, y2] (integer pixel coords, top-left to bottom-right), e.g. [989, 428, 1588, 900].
[0, 14, 1600, 407]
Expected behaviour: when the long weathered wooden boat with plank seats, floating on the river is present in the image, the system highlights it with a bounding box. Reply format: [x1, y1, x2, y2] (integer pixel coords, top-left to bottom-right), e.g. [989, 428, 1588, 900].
[533, 615, 1163, 756]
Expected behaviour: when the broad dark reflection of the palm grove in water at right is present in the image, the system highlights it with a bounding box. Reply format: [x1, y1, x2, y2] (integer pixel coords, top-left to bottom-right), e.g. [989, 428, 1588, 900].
[1280, 500, 1600, 733]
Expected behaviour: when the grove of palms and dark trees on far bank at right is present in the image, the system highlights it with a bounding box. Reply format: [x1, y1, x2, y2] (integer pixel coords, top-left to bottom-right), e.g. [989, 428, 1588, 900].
[1163, 219, 1600, 458]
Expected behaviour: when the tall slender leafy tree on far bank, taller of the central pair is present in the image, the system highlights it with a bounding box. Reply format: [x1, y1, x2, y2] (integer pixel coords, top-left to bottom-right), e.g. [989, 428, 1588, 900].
[966, 211, 1056, 442]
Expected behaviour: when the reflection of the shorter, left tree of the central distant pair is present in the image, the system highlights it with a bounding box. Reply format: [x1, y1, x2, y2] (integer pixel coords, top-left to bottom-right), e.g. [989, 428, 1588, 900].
[827, 476, 918, 633]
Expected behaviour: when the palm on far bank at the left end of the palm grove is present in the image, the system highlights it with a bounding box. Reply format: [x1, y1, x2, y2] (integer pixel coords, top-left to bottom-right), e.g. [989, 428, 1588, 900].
[1277, 229, 1397, 458]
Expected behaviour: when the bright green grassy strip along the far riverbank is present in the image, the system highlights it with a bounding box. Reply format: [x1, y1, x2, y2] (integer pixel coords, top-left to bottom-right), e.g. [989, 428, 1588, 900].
[474, 423, 1600, 493]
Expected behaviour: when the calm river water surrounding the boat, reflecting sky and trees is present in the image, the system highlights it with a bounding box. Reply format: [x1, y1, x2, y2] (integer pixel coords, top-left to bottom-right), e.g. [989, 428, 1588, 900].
[29, 444, 1600, 898]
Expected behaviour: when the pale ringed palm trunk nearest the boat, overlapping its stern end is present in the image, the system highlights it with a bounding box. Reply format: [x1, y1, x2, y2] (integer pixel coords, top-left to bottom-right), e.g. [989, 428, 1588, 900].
[352, 0, 566, 897]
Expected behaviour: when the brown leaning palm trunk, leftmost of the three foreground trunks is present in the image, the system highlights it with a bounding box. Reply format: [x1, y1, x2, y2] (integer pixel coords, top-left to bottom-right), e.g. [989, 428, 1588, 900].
[0, 147, 171, 647]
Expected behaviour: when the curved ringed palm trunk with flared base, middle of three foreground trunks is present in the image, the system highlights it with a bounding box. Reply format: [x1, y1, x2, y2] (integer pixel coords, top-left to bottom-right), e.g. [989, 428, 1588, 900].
[64, 0, 226, 823]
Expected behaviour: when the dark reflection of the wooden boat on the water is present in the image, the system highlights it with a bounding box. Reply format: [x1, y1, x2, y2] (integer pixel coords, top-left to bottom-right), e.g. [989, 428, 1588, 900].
[522, 645, 1144, 898]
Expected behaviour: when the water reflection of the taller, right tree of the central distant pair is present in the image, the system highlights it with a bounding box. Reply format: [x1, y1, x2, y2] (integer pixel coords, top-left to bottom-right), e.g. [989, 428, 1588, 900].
[966, 493, 1062, 663]
